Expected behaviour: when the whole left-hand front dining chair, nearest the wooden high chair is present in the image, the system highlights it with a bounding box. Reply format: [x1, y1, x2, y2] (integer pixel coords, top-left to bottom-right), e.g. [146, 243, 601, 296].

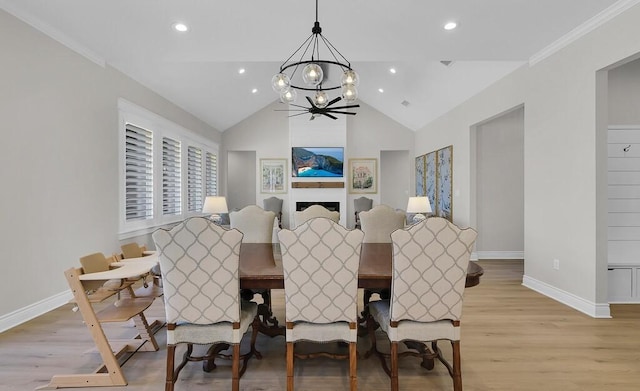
[152, 217, 260, 391]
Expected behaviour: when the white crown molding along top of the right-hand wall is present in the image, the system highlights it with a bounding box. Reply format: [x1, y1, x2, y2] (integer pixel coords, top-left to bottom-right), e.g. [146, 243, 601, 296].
[529, 0, 640, 66]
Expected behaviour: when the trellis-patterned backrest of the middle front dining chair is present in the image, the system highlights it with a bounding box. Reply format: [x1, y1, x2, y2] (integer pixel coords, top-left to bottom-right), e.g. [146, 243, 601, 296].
[278, 218, 364, 323]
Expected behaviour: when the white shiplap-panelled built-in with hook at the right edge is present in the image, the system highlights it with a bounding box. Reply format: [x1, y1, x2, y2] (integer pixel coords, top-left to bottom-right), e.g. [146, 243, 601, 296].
[608, 125, 640, 303]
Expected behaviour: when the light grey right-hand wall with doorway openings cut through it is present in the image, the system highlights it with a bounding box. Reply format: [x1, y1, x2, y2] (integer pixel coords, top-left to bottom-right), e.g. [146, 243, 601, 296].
[416, 5, 640, 316]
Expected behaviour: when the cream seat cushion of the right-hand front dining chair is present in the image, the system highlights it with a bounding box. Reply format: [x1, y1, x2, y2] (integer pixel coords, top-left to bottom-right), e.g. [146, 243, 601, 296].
[369, 300, 460, 342]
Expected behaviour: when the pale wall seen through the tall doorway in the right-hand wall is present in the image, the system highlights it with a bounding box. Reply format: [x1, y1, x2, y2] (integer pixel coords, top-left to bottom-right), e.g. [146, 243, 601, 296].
[476, 107, 524, 259]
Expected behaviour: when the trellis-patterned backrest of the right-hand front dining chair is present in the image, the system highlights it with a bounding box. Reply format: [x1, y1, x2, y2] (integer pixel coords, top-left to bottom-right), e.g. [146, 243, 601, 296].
[390, 217, 477, 322]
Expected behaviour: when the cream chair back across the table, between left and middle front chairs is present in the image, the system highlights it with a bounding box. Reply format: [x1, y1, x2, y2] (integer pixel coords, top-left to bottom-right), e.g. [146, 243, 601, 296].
[229, 205, 276, 243]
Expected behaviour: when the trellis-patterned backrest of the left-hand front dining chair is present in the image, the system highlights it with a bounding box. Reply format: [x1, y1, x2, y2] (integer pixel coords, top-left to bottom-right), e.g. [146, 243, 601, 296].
[153, 217, 242, 325]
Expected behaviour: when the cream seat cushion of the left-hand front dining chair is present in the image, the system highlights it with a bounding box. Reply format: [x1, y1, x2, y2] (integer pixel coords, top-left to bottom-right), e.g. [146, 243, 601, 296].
[167, 301, 258, 345]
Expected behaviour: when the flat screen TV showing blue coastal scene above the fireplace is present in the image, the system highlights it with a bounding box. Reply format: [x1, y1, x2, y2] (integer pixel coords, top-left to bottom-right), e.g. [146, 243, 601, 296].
[291, 147, 344, 178]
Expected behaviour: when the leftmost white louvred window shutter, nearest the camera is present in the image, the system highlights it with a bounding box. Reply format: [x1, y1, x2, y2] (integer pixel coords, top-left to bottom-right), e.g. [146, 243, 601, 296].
[125, 124, 153, 221]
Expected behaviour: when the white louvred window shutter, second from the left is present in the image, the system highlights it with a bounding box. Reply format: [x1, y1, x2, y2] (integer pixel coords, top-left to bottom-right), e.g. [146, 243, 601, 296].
[162, 137, 182, 216]
